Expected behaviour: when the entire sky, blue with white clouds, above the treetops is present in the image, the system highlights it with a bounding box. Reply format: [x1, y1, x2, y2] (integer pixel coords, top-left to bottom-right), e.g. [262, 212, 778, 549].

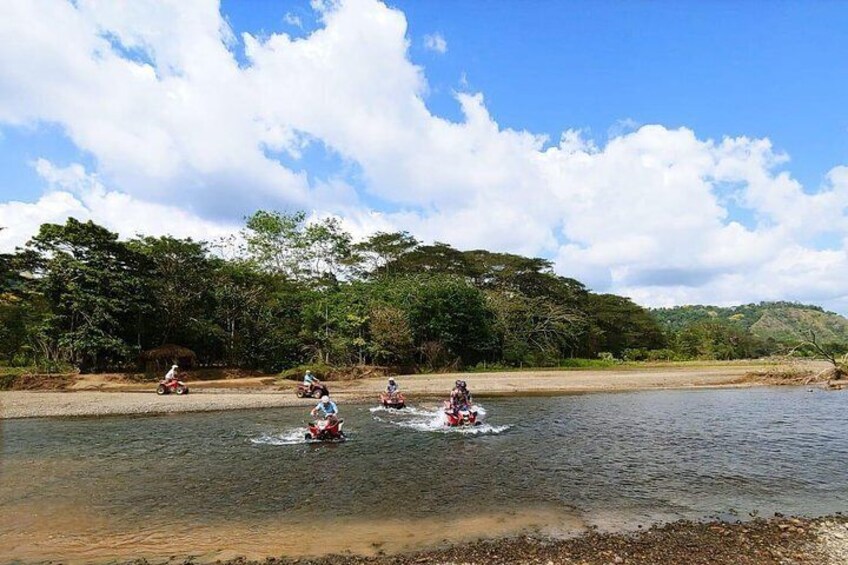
[0, 0, 848, 313]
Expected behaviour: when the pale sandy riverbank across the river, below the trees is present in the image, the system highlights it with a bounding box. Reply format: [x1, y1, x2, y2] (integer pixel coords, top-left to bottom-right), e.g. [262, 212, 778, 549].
[0, 363, 824, 418]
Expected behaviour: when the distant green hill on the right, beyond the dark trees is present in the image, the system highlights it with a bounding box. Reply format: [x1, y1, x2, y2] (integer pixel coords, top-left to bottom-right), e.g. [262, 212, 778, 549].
[650, 302, 848, 343]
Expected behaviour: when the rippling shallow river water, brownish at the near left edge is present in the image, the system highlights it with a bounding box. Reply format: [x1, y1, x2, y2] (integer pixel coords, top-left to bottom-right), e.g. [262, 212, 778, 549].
[0, 388, 848, 562]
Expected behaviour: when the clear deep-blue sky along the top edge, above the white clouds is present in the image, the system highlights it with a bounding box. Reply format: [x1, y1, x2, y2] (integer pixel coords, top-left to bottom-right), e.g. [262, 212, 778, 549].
[222, 0, 848, 187]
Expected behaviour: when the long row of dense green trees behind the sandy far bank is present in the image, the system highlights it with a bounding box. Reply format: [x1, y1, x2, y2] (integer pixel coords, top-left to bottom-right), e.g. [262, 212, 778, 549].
[0, 211, 836, 372]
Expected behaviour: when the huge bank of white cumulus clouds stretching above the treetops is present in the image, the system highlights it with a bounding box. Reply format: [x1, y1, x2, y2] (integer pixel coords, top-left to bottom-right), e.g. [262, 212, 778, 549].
[0, 0, 848, 310]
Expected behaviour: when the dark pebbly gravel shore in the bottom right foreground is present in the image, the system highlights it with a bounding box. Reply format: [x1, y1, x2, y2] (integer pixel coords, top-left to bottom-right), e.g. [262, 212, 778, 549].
[154, 516, 848, 565]
